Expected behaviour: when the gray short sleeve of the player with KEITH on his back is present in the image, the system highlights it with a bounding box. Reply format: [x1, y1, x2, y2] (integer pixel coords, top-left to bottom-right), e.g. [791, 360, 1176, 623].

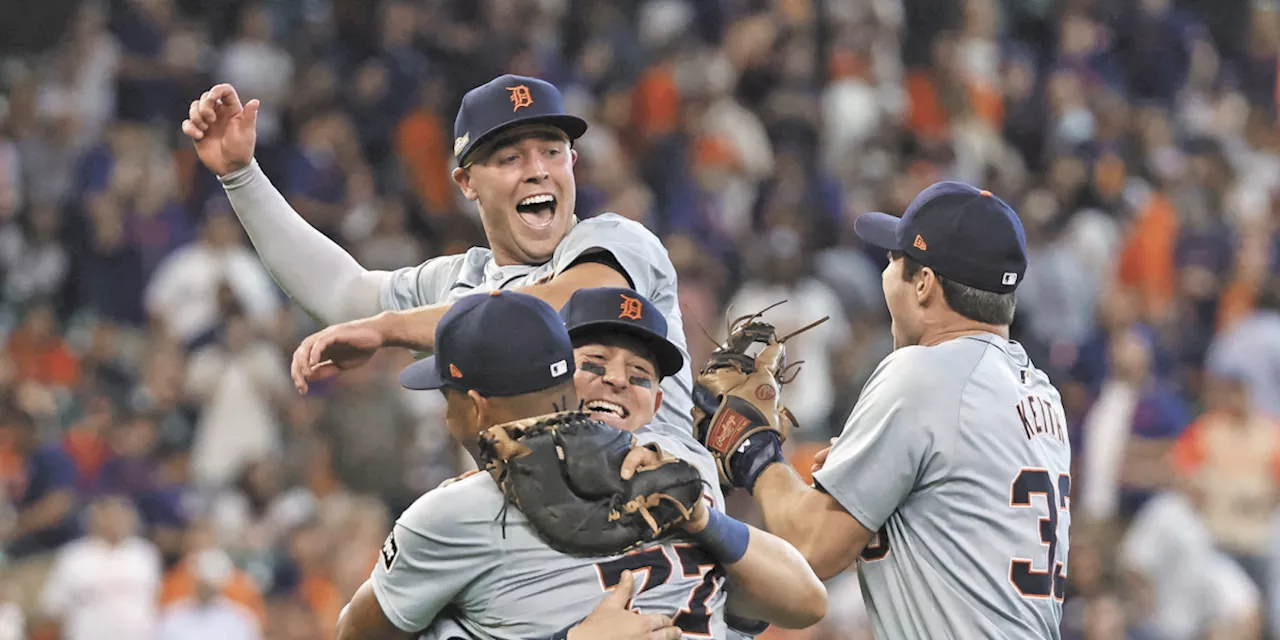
[814, 347, 959, 531]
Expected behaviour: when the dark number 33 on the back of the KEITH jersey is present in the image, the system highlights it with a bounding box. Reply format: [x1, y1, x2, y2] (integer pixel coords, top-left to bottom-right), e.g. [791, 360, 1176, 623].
[1009, 468, 1071, 600]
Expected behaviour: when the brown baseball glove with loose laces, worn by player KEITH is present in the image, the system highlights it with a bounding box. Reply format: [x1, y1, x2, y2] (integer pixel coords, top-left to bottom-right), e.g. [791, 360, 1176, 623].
[694, 301, 829, 489]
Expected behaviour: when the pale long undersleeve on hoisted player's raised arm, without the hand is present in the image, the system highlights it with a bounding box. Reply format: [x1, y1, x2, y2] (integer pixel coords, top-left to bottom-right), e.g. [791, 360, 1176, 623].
[219, 160, 388, 324]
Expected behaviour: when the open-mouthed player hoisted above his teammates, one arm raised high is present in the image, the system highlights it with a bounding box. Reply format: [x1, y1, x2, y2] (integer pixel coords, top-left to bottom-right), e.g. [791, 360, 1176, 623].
[182, 76, 692, 430]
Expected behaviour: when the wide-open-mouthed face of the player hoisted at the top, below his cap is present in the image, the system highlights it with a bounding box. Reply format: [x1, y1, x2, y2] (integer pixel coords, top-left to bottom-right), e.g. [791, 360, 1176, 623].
[453, 124, 577, 265]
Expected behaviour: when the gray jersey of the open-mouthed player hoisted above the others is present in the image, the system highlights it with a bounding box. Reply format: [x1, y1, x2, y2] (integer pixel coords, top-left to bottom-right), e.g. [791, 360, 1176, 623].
[381, 214, 694, 433]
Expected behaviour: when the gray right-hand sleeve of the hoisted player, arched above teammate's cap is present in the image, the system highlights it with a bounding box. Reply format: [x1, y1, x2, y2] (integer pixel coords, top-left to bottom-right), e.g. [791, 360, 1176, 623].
[552, 214, 676, 300]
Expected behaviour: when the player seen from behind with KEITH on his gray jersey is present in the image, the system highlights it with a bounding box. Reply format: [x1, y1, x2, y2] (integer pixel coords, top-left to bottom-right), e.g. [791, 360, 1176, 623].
[699, 182, 1071, 639]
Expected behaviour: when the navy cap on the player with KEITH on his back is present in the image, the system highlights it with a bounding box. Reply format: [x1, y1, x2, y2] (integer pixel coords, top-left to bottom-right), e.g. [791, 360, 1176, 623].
[854, 182, 1027, 293]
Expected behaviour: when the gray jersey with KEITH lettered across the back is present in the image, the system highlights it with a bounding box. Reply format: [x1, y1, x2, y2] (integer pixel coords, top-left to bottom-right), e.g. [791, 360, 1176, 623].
[814, 334, 1071, 640]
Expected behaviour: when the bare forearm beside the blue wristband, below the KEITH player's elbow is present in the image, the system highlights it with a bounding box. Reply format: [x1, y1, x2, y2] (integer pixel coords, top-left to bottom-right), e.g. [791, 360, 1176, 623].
[724, 527, 827, 628]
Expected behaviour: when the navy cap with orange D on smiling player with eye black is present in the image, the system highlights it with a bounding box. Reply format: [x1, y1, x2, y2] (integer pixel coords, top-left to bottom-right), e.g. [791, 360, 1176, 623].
[561, 287, 685, 378]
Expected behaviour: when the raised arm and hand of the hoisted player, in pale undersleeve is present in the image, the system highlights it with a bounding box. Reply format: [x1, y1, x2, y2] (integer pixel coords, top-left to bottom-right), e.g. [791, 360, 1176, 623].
[182, 84, 390, 324]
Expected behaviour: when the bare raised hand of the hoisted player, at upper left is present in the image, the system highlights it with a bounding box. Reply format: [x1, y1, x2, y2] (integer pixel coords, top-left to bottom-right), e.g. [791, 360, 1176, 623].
[182, 84, 261, 175]
